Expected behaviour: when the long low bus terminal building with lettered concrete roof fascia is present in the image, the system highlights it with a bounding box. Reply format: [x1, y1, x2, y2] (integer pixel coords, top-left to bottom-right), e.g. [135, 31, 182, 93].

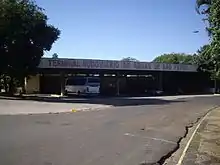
[25, 58, 210, 95]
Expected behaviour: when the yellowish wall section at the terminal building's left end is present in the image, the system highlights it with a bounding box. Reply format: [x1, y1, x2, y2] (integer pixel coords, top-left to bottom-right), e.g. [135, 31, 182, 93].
[25, 74, 40, 94]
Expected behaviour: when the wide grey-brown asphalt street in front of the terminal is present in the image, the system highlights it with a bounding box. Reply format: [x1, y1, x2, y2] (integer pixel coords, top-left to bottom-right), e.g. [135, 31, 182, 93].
[0, 96, 220, 165]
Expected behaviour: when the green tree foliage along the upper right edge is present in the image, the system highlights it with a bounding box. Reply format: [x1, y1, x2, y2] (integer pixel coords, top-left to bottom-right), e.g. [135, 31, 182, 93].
[197, 0, 220, 79]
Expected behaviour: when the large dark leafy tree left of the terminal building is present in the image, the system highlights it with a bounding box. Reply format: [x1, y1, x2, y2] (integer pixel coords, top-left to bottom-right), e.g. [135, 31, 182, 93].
[0, 0, 60, 93]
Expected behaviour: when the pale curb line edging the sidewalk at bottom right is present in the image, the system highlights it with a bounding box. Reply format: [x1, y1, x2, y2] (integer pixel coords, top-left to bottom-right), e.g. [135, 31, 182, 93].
[177, 107, 216, 165]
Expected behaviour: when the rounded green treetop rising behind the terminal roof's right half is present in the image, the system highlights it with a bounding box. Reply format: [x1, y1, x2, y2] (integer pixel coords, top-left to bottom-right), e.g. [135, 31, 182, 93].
[153, 53, 195, 64]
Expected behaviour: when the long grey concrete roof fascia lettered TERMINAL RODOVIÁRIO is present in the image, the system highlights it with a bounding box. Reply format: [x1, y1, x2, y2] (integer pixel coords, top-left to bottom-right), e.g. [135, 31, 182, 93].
[39, 58, 197, 72]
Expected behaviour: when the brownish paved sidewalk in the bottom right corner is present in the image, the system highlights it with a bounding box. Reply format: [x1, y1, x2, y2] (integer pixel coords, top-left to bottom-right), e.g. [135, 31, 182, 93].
[181, 108, 220, 165]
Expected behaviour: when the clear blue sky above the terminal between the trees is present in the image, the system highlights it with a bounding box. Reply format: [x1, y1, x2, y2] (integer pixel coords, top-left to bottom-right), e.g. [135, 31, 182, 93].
[36, 0, 208, 61]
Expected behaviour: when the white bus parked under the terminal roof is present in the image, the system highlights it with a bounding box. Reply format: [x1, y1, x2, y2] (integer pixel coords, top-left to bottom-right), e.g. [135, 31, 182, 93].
[65, 77, 100, 95]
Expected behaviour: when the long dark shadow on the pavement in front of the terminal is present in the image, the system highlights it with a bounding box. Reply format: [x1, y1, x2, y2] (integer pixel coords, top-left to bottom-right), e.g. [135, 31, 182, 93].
[0, 96, 185, 106]
